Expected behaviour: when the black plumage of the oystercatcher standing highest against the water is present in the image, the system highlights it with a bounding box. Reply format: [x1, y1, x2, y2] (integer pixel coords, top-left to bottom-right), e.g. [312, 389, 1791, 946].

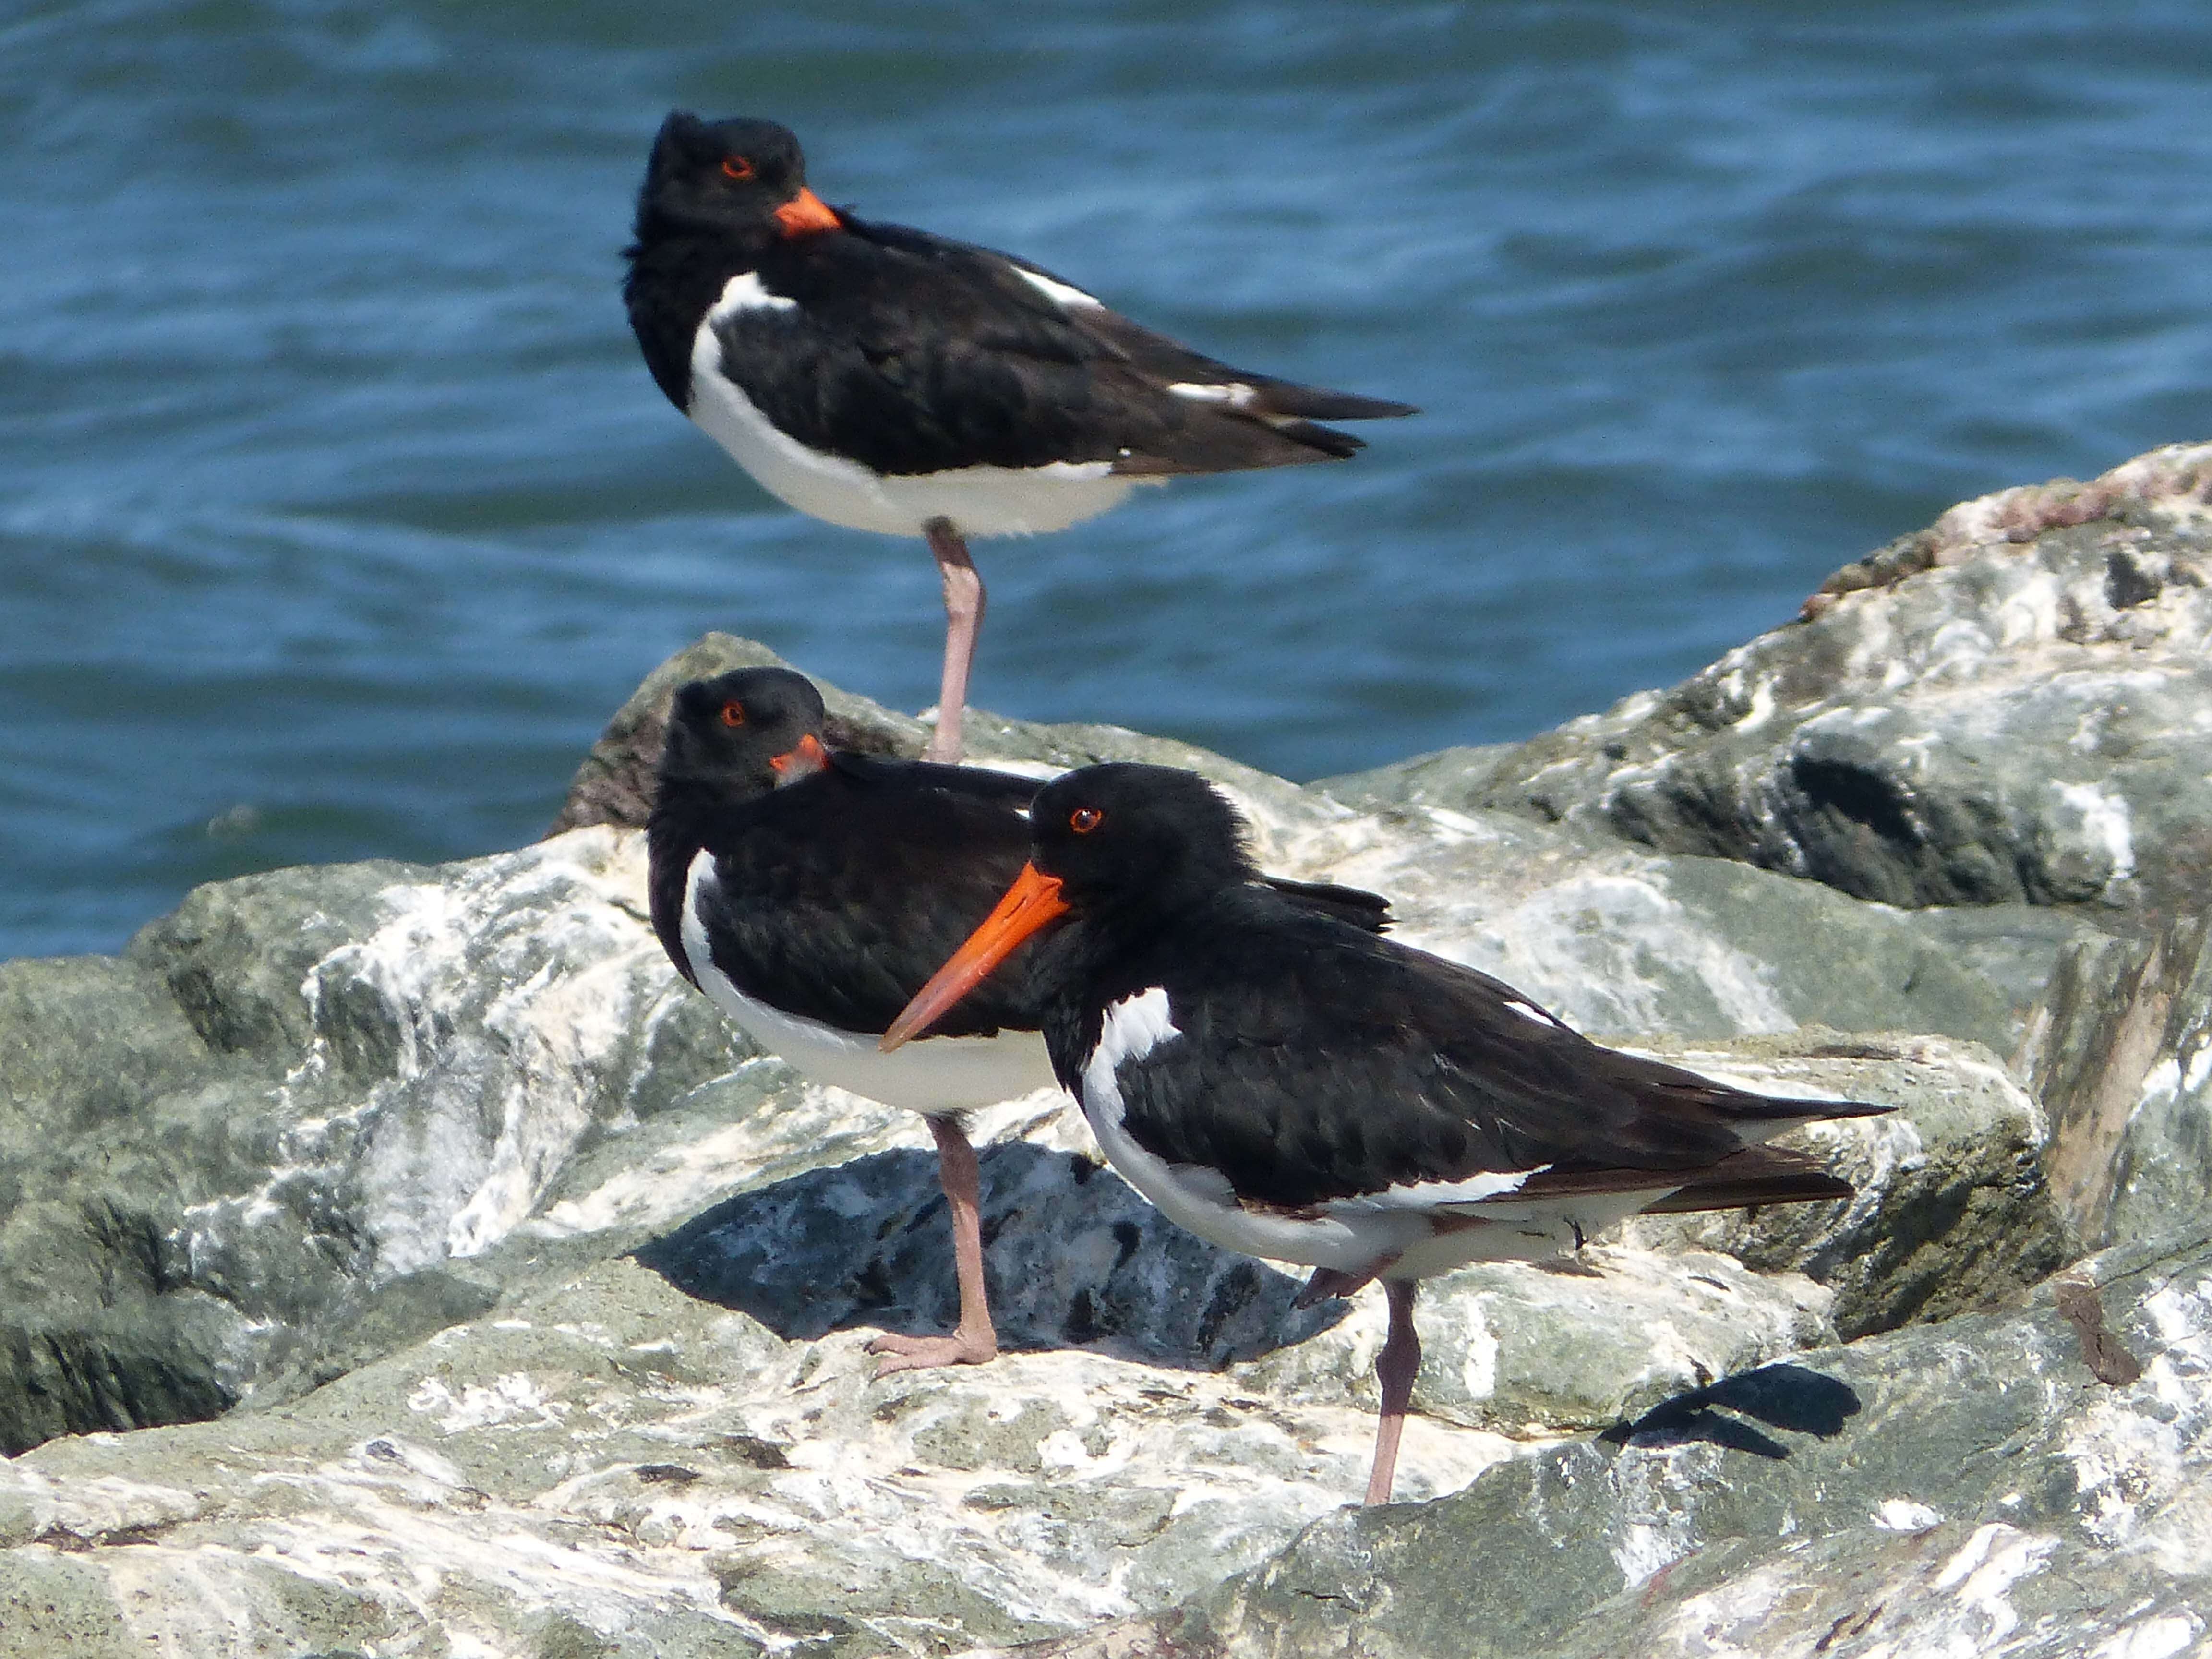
[624, 110, 1414, 476]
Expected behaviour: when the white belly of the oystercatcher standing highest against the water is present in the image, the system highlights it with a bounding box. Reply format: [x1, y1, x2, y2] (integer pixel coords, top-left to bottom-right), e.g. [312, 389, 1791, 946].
[690, 312, 1166, 535]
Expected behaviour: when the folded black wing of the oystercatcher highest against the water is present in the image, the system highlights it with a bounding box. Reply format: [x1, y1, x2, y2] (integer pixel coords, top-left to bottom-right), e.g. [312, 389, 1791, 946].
[717, 215, 1409, 476]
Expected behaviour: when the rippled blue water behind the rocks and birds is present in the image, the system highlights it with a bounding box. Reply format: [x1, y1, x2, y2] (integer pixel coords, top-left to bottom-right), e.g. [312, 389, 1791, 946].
[0, 0, 2212, 956]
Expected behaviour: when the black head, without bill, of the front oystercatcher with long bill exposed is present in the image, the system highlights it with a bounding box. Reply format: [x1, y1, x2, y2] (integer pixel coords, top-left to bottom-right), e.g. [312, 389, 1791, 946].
[1029, 761, 1259, 914]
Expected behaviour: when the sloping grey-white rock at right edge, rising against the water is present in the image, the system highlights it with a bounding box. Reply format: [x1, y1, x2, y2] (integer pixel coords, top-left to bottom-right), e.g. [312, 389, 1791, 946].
[1334, 445, 2212, 914]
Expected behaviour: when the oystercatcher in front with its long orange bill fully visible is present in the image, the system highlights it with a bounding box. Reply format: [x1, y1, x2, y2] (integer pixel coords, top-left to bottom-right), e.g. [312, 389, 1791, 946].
[883, 765, 1889, 1504]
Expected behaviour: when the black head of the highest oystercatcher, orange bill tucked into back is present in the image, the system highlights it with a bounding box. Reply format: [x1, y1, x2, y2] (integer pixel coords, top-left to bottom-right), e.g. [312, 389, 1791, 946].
[637, 110, 836, 241]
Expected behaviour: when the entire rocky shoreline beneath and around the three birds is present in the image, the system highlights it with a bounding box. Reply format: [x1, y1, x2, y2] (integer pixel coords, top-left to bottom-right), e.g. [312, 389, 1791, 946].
[0, 447, 2212, 1659]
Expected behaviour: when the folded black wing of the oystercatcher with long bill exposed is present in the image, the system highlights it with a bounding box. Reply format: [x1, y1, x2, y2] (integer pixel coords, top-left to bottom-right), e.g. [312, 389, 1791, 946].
[1088, 889, 1885, 1208]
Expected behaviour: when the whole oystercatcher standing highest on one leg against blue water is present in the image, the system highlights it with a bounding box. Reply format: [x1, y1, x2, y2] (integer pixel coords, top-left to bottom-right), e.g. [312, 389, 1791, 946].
[624, 110, 1414, 761]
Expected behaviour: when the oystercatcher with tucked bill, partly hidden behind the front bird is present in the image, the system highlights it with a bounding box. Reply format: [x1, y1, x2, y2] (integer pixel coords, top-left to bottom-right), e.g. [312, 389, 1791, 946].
[646, 668, 1387, 1374]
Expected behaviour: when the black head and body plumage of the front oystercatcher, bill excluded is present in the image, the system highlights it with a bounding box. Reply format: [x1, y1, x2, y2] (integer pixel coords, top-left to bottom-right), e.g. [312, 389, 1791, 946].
[1031, 765, 1887, 1210]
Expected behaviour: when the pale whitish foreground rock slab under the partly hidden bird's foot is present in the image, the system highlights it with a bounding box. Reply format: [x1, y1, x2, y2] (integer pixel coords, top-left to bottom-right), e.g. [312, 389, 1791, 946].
[0, 1261, 1515, 1659]
